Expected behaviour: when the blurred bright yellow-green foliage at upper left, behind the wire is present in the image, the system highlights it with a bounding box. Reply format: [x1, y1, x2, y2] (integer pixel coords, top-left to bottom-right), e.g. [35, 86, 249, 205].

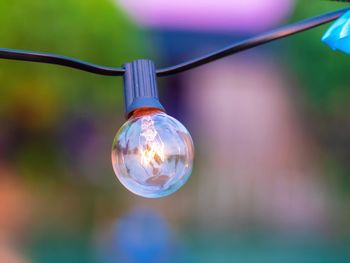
[0, 0, 145, 113]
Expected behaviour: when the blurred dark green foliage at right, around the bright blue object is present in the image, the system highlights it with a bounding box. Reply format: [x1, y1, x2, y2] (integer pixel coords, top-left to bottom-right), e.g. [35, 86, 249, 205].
[285, 1, 350, 114]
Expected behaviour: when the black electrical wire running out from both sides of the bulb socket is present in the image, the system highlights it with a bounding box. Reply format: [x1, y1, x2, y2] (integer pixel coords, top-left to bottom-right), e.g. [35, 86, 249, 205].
[0, 8, 350, 76]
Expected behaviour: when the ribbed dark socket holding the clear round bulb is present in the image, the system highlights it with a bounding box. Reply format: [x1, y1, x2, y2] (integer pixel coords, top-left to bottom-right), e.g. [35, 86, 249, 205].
[123, 59, 165, 118]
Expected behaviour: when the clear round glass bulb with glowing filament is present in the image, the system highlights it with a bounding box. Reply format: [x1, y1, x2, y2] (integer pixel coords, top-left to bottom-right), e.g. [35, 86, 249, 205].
[112, 109, 194, 198]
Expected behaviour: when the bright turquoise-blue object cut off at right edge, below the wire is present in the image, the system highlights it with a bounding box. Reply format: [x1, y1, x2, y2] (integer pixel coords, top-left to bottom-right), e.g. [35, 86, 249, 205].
[322, 11, 350, 54]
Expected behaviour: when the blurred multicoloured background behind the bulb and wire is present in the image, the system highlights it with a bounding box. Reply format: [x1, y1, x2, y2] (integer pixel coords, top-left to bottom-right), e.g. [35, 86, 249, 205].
[0, 0, 350, 263]
